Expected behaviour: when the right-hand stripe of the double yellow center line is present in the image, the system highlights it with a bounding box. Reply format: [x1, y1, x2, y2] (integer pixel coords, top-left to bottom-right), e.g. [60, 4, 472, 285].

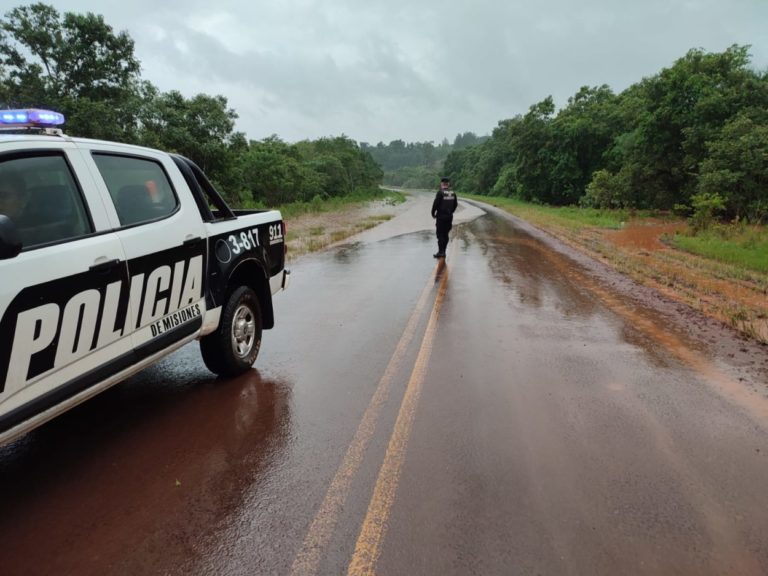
[347, 242, 455, 576]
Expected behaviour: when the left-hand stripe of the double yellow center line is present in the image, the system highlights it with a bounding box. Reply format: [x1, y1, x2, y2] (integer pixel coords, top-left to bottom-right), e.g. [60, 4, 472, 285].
[291, 261, 443, 576]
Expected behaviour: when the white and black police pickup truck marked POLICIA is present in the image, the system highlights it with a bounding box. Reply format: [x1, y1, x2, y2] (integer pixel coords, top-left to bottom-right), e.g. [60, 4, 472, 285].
[0, 110, 288, 444]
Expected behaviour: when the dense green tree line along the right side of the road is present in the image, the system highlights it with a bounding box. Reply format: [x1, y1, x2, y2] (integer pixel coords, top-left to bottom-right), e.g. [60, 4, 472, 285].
[445, 45, 768, 222]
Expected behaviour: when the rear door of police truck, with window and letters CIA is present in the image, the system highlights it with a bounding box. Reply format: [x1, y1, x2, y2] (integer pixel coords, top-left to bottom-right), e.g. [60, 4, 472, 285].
[81, 145, 207, 358]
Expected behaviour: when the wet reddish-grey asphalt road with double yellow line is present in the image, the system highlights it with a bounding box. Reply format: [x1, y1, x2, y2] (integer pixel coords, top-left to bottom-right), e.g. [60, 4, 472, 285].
[0, 196, 768, 575]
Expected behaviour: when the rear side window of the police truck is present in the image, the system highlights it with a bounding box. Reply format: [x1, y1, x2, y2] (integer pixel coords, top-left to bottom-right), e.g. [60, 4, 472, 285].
[93, 153, 179, 226]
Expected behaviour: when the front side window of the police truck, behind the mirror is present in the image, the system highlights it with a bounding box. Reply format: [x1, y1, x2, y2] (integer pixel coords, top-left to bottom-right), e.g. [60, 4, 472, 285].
[0, 153, 93, 249]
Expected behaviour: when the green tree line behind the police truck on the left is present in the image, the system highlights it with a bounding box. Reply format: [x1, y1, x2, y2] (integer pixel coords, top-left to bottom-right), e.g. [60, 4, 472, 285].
[0, 3, 383, 205]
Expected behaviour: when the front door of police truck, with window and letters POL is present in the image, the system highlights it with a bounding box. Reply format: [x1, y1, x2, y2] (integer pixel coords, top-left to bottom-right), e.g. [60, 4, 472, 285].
[0, 148, 133, 433]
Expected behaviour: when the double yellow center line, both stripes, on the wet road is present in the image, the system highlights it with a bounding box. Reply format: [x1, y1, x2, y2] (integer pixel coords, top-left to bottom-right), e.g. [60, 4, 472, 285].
[291, 248, 455, 576]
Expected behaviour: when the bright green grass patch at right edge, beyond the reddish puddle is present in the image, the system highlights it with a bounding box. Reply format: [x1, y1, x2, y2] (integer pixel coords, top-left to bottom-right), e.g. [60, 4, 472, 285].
[671, 225, 768, 272]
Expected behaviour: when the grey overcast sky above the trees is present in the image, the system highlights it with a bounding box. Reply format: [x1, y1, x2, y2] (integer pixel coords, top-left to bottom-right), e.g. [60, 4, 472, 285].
[7, 0, 768, 143]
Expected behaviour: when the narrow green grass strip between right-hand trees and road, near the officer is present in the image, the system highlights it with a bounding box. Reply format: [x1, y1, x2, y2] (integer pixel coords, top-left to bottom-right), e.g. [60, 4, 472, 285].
[462, 194, 658, 231]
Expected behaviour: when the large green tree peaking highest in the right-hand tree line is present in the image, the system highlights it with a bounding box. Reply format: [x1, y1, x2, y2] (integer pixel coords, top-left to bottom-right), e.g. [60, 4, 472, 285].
[608, 46, 768, 209]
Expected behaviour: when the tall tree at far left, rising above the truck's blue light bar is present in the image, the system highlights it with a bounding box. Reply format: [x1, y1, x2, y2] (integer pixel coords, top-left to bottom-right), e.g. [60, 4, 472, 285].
[0, 3, 142, 141]
